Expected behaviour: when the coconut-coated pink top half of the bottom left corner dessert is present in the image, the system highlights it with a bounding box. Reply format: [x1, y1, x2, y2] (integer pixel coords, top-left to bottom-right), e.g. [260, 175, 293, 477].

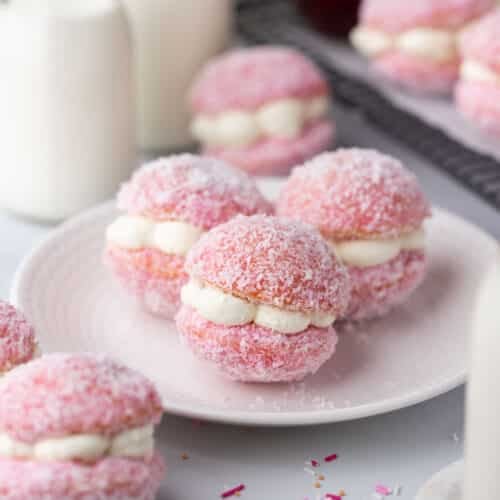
[0, 354, 162, 443]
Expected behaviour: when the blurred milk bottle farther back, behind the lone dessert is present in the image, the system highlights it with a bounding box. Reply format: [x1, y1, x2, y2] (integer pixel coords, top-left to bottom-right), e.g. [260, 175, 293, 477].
[123, 0, 232, 151]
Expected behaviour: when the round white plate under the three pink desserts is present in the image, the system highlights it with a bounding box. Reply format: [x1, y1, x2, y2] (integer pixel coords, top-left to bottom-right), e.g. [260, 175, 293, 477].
[11, 182, 496, 425]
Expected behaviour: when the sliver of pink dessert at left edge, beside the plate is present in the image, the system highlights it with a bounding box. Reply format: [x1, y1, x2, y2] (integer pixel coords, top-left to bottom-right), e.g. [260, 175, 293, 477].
[0, 301, 37, 376]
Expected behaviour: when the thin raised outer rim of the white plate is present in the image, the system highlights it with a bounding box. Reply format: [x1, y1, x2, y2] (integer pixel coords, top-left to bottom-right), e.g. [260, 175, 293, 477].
[10, 200, 497, 426]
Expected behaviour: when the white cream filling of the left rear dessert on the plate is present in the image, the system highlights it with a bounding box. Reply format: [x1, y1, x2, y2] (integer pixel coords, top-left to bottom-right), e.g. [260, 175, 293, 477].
[106, 215, 203, 256]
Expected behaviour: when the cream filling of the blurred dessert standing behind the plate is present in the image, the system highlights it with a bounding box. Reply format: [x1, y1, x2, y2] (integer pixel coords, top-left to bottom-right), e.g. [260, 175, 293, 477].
[191, 96, 330, 147]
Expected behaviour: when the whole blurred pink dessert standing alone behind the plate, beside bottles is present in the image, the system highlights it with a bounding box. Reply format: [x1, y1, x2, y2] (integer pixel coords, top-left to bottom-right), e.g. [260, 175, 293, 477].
[190, 47, 335, 175]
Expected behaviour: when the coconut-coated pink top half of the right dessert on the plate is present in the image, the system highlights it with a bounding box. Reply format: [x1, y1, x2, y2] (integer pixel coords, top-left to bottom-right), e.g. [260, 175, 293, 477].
[277, 148, 430, 241]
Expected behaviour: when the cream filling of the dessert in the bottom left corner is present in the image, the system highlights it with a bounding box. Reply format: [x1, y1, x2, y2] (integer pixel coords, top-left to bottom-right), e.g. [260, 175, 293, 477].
[0, 425, 154, 462]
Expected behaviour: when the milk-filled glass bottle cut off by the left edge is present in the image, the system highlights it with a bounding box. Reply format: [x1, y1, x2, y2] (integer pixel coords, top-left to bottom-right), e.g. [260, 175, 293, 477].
[0, 0, 136, 220]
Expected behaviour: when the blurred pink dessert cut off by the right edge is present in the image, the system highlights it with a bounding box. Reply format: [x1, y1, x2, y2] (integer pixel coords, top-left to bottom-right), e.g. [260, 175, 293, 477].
[455, 8, 500, 137]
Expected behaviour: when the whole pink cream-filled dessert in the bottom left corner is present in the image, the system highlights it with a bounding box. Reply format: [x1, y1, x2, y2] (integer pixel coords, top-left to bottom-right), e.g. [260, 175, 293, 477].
[0, 354, 165, 500]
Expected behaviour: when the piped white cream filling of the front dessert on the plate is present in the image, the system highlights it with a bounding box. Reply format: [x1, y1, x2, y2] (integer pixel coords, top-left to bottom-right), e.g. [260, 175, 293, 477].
[181, 279, 335, 335]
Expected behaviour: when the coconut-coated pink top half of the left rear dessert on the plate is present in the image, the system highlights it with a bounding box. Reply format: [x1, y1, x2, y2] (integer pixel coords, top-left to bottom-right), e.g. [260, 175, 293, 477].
[118, 154, 272, 229]
